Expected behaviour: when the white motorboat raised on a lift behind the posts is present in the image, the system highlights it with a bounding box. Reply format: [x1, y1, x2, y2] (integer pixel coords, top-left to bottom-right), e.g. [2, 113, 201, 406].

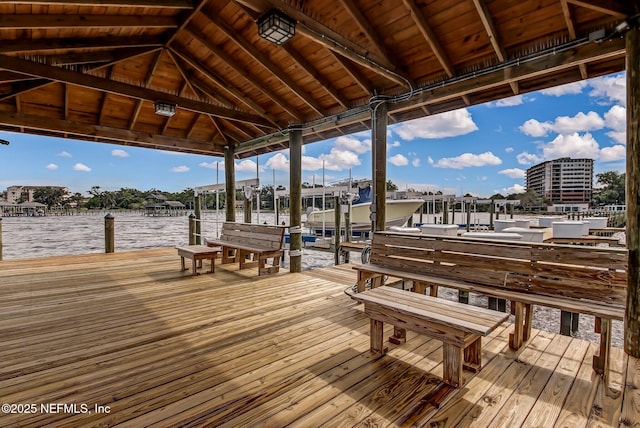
[305, 181, 424, 234]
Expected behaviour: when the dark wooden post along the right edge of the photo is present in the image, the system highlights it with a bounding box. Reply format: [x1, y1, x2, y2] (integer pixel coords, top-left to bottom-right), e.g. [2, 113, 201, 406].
[624, 20, 640, 358]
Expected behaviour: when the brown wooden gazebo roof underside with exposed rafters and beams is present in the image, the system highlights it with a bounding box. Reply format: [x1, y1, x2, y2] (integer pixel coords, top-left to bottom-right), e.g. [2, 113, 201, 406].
[0, 0, 640, 157]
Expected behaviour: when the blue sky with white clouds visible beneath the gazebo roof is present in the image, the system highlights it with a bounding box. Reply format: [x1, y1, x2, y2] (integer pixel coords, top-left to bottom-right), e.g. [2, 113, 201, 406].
[0, 73, 626, 197]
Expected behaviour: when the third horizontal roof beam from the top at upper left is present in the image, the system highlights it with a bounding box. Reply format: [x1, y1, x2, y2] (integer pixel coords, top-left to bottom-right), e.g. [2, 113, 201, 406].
[0, 37, 164, 54]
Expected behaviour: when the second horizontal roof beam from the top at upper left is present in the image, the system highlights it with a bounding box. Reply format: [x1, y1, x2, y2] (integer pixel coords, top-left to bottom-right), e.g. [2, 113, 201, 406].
[0, 14, 178, 30]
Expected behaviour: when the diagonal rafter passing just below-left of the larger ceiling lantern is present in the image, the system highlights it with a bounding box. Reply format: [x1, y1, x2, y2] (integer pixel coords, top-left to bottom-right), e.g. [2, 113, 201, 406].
[201, 11, 326, 116]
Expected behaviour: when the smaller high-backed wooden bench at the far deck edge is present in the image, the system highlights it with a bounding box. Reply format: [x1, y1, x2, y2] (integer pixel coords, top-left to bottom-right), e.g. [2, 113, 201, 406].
[206, 222, 284, 275]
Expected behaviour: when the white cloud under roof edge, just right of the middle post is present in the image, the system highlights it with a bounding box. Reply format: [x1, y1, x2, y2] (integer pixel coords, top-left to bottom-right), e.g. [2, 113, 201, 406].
[393, 109, 478, 141]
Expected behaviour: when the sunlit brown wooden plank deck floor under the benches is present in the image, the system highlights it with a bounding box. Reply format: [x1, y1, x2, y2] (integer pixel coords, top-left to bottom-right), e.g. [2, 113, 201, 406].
[0, 249, 640, 428]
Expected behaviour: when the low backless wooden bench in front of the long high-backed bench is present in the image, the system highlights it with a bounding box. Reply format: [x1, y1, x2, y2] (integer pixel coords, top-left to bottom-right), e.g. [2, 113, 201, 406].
[353, 287, 509, 388]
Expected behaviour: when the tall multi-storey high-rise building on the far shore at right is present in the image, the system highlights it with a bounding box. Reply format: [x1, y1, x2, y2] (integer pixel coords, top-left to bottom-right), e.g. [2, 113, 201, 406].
[526, 158, 593, 204]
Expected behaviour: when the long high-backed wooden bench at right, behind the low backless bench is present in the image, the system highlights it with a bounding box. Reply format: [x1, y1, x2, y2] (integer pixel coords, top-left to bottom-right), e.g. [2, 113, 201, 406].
[354, 232, 628, 379]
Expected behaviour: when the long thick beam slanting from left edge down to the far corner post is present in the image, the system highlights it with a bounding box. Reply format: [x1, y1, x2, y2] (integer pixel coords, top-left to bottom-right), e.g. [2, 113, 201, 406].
[0, 55, 273, 128]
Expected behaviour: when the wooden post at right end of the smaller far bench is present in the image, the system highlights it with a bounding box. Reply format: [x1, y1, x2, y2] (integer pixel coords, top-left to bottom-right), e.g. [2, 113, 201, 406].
[289, 129, 302, 272]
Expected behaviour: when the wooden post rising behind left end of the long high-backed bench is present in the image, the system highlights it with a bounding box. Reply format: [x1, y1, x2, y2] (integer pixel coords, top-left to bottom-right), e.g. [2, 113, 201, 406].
[371, 103, 388, 232]
